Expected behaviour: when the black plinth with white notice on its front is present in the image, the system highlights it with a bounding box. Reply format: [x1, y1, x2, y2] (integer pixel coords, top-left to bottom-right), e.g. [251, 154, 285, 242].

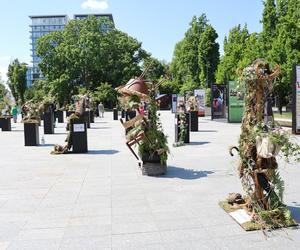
[70, 120, 88, 153]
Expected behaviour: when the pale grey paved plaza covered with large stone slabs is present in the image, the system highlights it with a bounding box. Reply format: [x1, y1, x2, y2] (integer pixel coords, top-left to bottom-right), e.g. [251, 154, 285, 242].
[0, 111, 300, 250]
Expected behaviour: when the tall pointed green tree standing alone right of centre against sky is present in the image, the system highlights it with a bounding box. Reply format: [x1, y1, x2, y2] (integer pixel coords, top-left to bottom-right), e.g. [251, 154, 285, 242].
[170, 14, 219, 91]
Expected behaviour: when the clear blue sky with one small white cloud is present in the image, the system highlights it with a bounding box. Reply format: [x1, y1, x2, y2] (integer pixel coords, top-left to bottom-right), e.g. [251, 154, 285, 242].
[0, 0, 263, 79]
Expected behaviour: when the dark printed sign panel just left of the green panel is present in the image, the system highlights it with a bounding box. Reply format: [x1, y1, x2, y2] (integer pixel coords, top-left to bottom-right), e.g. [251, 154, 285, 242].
[211, 84, 226, 119]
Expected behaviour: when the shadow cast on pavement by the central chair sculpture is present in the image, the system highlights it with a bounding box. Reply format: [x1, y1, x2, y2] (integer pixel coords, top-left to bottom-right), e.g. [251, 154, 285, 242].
[162, 166, 214, 180]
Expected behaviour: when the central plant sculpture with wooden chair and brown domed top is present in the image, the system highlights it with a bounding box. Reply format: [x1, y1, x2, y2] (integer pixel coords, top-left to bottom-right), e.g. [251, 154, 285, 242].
[118, 78, 169, 176]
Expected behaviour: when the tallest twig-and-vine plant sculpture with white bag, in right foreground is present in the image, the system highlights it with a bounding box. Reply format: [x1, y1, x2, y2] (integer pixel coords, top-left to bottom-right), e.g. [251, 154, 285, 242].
[223, 60, 299, 229]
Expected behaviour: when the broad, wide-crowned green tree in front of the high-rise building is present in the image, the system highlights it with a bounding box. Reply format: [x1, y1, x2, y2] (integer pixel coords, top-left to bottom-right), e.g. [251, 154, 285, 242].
[37, 17, 149, 102]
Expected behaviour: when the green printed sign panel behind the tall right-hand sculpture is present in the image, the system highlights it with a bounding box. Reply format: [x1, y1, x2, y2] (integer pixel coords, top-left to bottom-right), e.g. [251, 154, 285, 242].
[228, 81, 245, 122]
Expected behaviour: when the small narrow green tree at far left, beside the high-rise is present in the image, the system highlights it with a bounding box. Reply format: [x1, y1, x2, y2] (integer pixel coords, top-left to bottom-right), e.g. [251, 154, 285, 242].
[7, 59, 27, 104]
